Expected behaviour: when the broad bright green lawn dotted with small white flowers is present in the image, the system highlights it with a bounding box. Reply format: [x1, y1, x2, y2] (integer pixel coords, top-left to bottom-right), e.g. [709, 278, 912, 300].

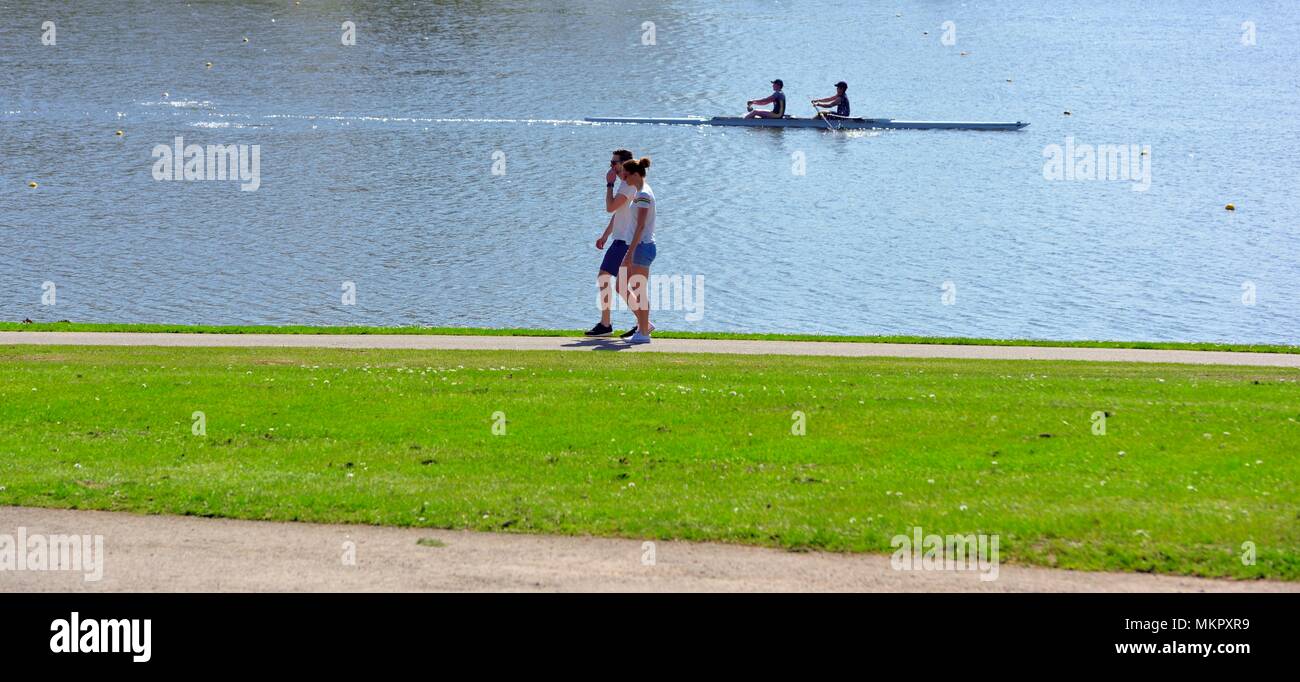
[0, 346, 1300, 579]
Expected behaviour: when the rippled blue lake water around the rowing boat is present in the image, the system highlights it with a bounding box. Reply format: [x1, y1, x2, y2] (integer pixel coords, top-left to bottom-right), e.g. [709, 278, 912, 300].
[0, 0, 1300, 343]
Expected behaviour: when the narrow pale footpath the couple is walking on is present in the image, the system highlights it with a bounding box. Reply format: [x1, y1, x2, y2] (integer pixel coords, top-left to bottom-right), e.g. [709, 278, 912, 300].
[0, 331, 1300, 368]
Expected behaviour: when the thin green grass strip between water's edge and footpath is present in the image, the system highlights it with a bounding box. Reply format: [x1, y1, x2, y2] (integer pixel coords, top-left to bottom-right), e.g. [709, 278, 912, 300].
[0, 322, 1300, 353]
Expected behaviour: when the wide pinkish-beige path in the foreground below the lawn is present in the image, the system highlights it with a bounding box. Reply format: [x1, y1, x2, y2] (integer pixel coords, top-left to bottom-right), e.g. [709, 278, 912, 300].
[0, 507, 1300, 592]
